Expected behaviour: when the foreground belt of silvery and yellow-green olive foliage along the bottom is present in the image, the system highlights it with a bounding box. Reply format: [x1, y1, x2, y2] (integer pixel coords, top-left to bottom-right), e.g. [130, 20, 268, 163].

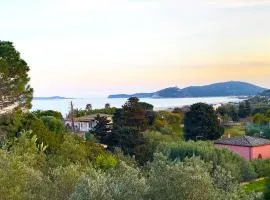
[0, 127, 258, 200]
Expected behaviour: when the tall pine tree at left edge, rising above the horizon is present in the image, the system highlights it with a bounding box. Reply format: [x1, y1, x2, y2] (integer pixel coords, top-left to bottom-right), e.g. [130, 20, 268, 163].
[0, 41, 33, 109]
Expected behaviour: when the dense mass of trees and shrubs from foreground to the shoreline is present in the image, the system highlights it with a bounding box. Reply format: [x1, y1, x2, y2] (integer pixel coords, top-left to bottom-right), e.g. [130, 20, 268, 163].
[0, 41, 269, 200]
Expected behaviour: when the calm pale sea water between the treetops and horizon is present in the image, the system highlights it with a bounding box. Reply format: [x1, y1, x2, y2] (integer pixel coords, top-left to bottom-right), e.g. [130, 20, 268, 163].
[32, 97, 241, 116]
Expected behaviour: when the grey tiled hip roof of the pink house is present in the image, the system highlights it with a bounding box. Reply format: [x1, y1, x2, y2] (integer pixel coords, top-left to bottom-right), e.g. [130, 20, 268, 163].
[214, 135, 270, 147]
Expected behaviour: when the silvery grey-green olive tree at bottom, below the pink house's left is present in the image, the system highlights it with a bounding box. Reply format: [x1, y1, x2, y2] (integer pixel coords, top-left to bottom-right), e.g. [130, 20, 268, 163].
[147, 154, 250, 200]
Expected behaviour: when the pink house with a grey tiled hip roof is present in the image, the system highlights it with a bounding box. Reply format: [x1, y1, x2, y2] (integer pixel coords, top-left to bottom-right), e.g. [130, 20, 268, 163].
[214, 136, 270, 160]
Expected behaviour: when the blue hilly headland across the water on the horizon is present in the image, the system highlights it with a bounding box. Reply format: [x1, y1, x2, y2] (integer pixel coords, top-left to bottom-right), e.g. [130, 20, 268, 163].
[108, 81, 265, 98]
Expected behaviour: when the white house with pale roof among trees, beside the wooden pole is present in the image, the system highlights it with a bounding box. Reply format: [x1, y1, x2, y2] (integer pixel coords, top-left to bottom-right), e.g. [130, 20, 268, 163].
[65, 114, 112, 132]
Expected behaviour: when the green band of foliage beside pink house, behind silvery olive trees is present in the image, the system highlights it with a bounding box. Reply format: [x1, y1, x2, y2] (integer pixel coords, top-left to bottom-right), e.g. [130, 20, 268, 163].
[160, 141, 257, 182]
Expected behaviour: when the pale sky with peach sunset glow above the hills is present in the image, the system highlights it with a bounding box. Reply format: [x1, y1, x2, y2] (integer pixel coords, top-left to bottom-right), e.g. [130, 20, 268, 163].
[0, 0, 270, 97]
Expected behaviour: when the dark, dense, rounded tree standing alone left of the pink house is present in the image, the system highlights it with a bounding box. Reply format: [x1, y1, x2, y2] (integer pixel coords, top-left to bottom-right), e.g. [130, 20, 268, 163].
[184, 103, 224, 140]
